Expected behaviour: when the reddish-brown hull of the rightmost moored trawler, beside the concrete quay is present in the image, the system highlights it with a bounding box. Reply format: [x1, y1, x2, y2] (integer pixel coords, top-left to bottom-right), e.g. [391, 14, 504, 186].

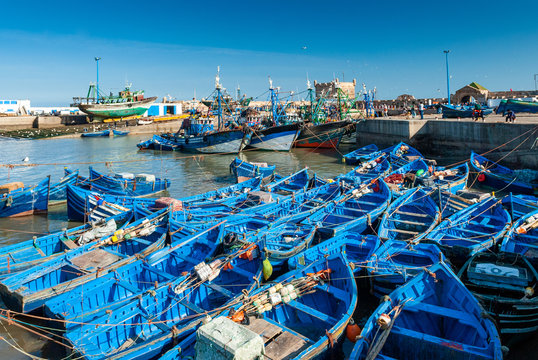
[294, 121, 352, 149]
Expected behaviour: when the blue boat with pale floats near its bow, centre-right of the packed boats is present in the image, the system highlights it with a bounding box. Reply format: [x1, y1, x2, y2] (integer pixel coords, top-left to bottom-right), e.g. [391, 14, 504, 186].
[304, 180, 392, 239]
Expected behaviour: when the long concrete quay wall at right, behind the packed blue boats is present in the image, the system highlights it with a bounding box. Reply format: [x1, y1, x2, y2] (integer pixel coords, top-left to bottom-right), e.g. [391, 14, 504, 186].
[357, 115, 538, 169]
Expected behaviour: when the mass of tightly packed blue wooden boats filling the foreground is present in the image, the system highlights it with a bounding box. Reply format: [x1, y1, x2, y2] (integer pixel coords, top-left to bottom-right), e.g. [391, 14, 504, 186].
[0, 143, 538, 359]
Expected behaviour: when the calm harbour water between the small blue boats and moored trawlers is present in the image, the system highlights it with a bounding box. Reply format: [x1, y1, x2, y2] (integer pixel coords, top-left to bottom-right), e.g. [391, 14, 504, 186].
[0, 135, 538, 360]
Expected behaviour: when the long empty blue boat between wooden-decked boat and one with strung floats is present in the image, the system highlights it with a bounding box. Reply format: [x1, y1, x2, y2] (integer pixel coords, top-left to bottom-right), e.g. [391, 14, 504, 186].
[44, 222, 224, 330]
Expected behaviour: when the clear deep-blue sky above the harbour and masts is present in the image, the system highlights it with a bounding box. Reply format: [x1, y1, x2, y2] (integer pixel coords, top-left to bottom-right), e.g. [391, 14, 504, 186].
[0, 0, 538, 105]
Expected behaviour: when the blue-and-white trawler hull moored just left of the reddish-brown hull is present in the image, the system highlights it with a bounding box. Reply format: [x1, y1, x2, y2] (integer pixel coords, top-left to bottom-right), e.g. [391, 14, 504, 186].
[247, 123, 301, 151]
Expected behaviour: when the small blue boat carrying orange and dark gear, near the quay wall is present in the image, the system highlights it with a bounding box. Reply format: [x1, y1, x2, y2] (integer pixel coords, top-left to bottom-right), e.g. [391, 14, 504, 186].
[384, 158, 429, 198]
